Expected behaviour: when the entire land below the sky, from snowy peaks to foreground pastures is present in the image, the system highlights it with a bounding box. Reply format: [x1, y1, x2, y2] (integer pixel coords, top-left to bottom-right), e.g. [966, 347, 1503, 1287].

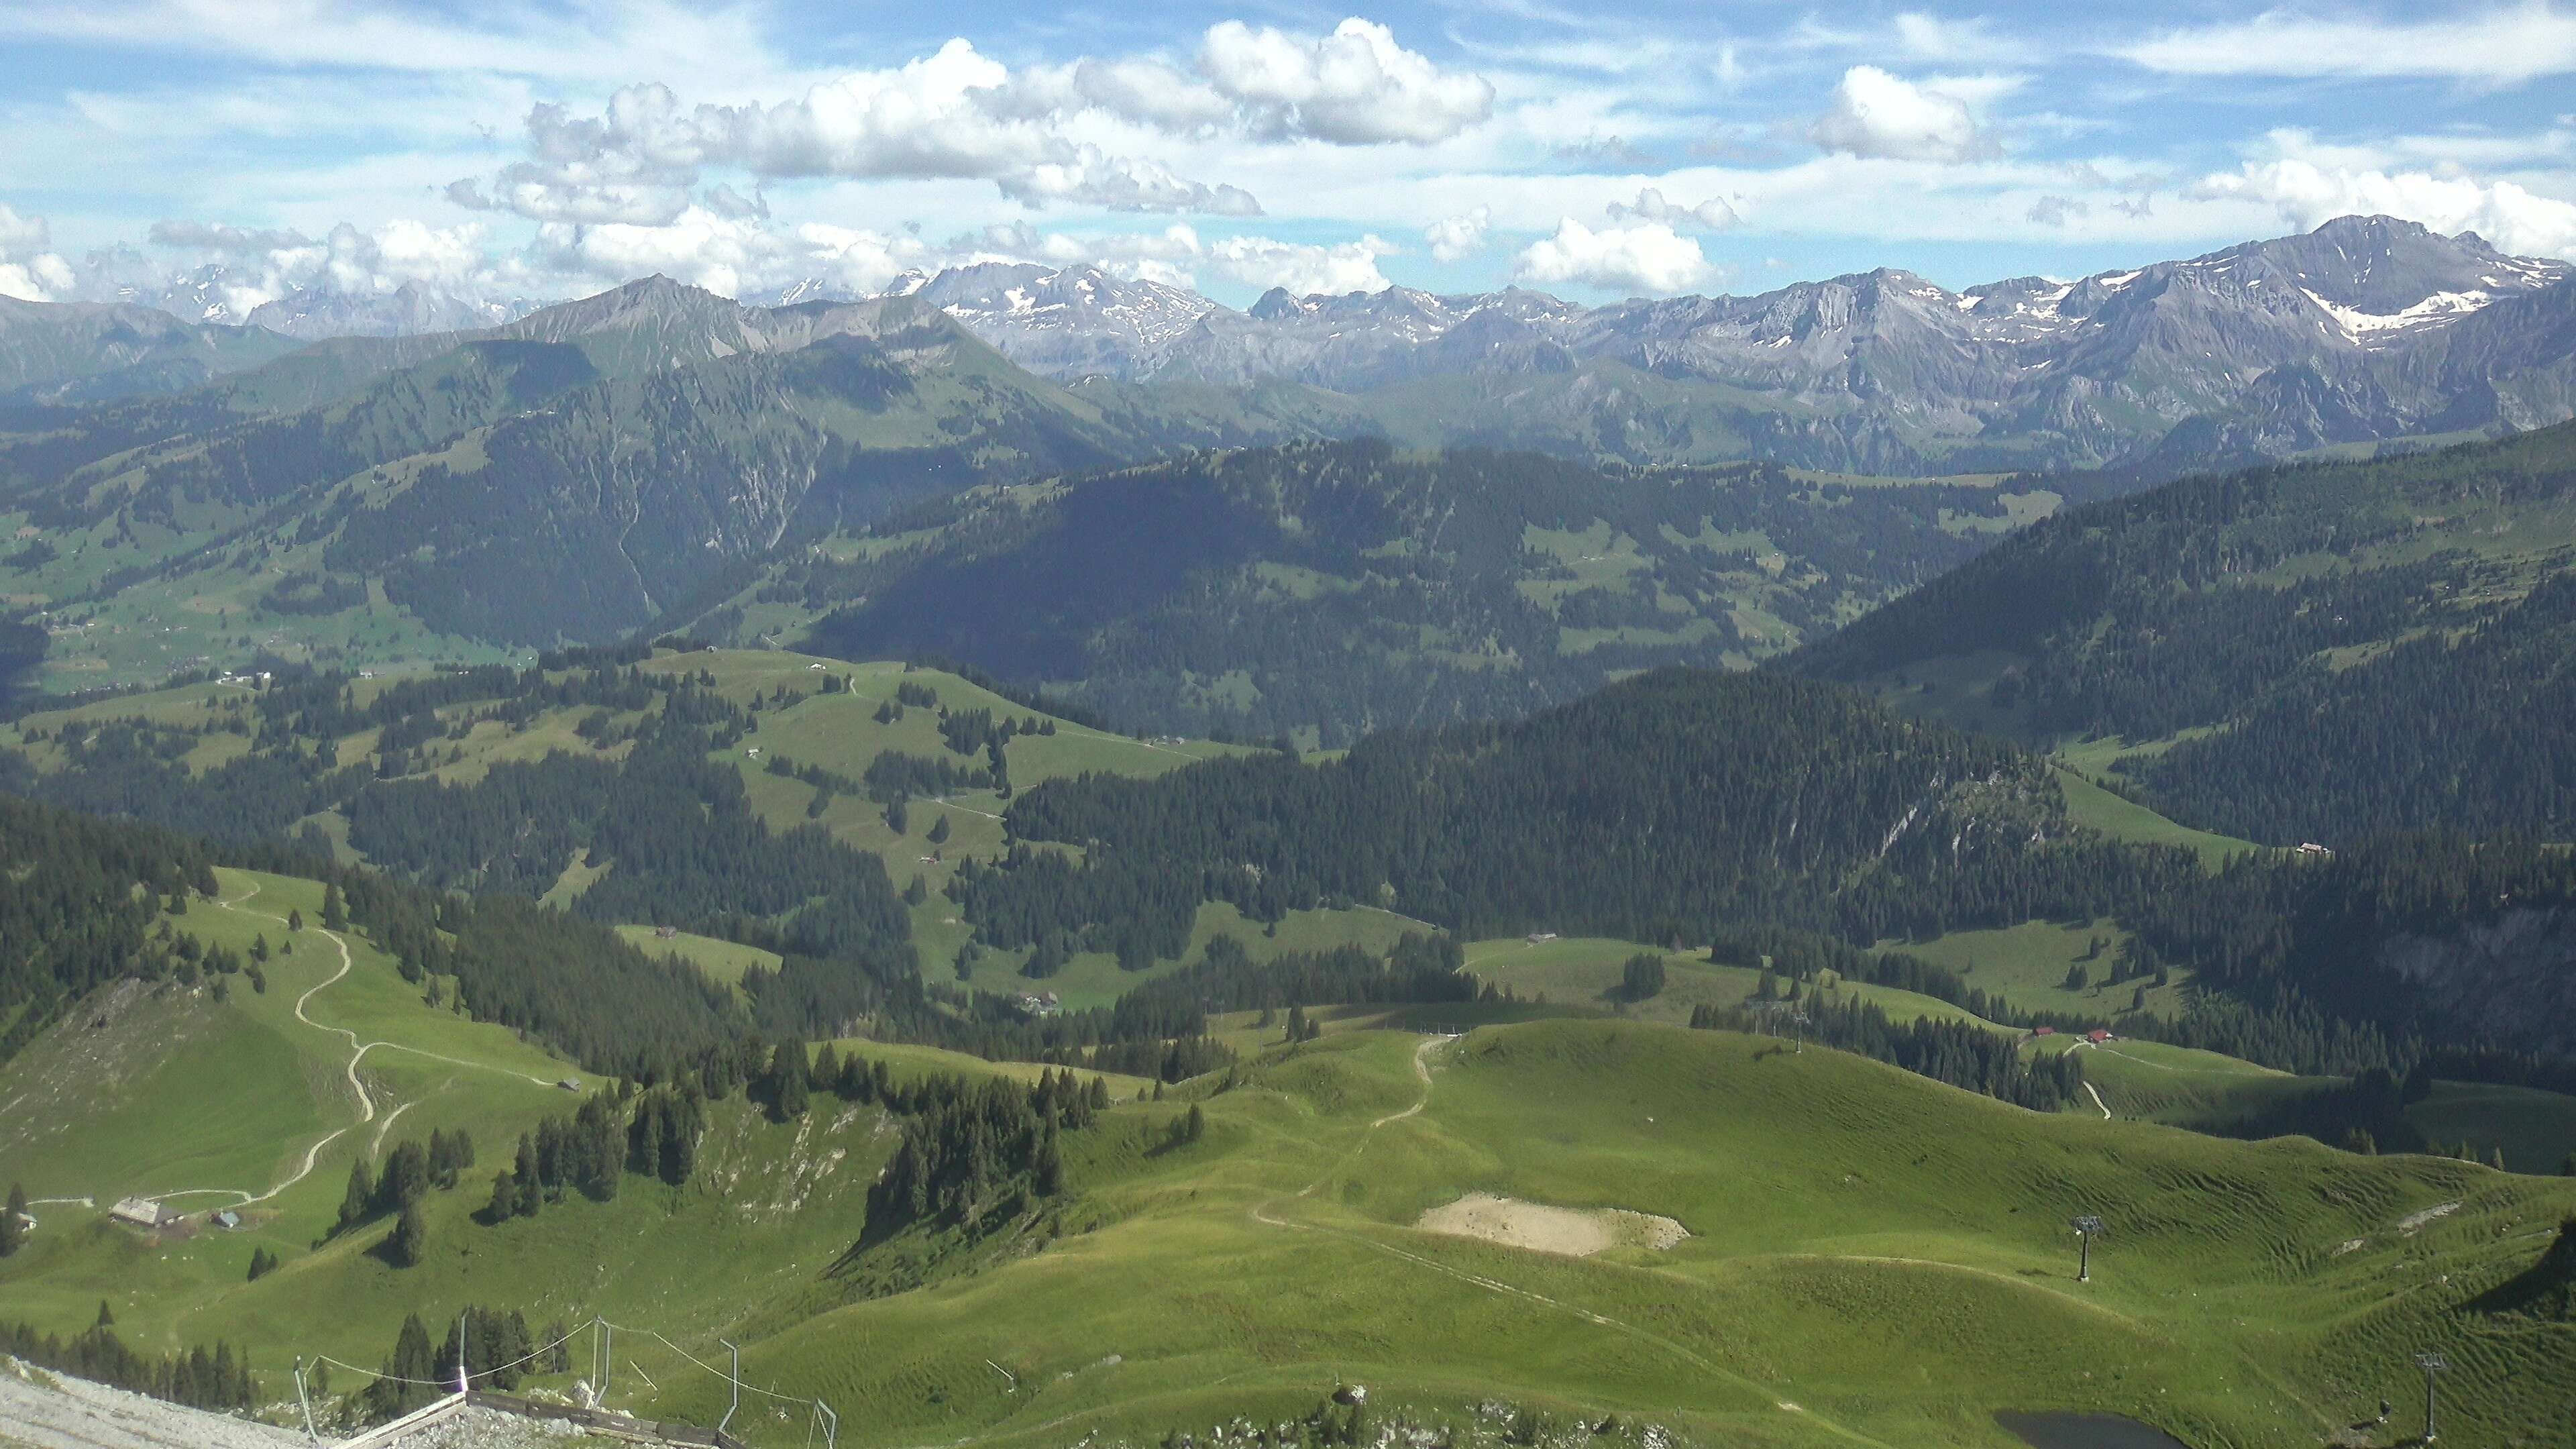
[0, 209, 2576, 1449]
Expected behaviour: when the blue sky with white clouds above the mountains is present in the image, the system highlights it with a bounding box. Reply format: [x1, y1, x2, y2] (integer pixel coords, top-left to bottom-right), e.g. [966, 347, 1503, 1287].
[0, 0, 2576, 315]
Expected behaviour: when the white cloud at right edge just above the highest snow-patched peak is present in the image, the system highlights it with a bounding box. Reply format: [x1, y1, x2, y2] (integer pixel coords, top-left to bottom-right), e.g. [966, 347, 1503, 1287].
[2192, 157, 2576, 258]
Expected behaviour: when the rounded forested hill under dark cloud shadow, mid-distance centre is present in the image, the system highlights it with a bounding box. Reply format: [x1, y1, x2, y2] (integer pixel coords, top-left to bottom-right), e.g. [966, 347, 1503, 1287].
[783, 441, 2071, 745]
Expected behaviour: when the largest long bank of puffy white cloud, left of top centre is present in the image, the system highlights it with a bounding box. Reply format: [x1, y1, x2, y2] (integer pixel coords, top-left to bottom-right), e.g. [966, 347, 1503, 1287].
[445, 18, 1494, 227]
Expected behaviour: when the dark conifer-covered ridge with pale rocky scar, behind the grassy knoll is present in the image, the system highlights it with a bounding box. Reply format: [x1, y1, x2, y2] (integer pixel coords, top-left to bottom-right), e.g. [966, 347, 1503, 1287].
[951, 670, 2576, 1073]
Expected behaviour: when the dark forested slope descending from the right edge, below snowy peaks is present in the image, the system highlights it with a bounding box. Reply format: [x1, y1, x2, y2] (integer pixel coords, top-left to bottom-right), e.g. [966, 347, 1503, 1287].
[1785, 425, 2576, 843]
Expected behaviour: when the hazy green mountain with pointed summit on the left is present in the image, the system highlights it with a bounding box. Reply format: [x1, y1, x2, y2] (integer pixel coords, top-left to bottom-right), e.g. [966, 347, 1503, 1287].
[0, 278, 1313, 645]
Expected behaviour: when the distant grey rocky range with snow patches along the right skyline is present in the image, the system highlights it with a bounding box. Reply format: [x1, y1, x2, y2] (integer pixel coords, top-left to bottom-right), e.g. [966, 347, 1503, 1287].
[922, 217, 2576, 474]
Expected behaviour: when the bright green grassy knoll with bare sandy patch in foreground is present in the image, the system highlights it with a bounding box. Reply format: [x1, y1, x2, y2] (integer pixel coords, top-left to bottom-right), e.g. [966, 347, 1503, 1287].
[639, 1021, 2576, 1446]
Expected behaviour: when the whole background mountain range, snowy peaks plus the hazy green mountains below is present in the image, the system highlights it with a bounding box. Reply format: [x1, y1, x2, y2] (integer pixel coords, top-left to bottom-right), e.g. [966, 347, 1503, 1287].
[0, 219, 2576, 727]
